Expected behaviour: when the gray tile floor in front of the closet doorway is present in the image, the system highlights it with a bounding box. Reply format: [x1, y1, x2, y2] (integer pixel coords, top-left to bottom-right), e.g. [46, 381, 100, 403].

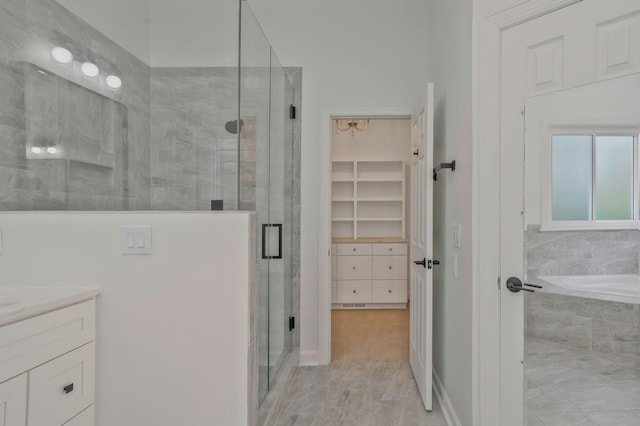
[276, 362, 447, 426]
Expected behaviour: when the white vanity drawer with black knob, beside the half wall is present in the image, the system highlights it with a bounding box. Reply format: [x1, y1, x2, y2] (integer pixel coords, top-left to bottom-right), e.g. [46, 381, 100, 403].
[28, 343, 95, 426]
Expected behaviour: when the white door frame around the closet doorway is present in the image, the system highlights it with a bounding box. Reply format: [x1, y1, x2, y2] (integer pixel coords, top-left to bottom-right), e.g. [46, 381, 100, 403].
[318, 105, 414, 365]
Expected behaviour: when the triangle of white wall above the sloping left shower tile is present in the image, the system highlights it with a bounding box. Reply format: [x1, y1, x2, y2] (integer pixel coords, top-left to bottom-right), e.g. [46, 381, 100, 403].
[56, 0, 154, 64]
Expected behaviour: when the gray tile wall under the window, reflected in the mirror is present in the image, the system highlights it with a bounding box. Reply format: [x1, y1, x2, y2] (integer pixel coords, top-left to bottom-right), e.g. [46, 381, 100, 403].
[526, 225, 640, 279]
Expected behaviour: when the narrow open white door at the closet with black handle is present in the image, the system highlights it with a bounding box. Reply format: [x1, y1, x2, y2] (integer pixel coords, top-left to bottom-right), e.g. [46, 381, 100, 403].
[409, 83, 433, 410]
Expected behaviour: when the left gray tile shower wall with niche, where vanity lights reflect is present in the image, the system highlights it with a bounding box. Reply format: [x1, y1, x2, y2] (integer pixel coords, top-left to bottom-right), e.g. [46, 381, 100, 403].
[0, 0, 151, 210]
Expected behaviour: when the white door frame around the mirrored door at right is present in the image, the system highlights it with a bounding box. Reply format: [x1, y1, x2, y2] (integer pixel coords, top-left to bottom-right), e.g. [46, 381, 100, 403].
[472, 0, 581, 426]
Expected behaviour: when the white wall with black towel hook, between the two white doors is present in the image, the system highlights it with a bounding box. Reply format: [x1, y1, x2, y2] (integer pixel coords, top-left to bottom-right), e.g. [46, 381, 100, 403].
[426, 0, 473, 425]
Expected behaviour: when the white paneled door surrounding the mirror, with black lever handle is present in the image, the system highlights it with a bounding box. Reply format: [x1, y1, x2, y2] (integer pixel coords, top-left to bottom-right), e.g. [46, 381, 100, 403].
[500, 0, 640, 426]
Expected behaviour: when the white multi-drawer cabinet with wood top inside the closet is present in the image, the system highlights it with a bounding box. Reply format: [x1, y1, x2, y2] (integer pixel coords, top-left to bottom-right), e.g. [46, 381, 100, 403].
[331, 238, 408, 309]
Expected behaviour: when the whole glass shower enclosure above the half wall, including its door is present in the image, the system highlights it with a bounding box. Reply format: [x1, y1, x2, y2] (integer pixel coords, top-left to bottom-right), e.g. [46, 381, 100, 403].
[0, 0, 299, 412]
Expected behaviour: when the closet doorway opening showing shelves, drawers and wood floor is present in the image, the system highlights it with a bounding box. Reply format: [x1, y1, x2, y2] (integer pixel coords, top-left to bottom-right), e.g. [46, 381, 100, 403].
[331, 117, 412, 362]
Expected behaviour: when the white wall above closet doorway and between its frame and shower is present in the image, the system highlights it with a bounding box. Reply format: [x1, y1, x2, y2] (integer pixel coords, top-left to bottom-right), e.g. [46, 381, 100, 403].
[249, 0, 428, 366]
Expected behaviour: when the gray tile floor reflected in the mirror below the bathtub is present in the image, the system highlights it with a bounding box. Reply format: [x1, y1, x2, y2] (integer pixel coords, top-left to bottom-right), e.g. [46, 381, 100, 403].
[525, 338, 640, 426]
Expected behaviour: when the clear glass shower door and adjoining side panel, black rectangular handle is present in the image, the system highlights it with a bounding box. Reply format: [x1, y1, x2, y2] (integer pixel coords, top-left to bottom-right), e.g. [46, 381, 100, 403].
[238, 1, 293, 403]
